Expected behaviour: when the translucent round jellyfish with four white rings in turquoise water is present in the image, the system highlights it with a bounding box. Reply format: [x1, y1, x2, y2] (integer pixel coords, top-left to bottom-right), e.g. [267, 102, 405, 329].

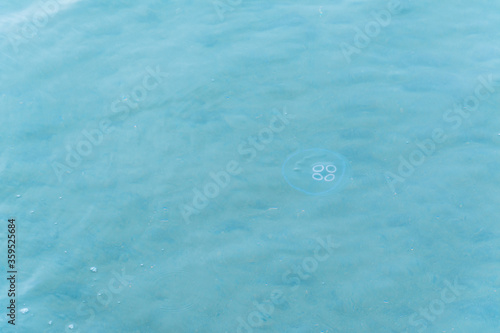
[281, 148, 349, 195]
